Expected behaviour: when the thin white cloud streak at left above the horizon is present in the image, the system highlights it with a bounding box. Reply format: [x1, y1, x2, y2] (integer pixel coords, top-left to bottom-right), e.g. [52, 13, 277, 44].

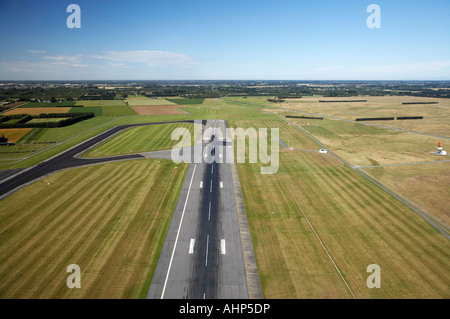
[91, 51, 193, 67]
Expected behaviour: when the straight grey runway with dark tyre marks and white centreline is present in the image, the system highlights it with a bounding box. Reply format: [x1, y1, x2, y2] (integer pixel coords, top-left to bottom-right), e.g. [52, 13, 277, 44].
[147, 120, 249, 299]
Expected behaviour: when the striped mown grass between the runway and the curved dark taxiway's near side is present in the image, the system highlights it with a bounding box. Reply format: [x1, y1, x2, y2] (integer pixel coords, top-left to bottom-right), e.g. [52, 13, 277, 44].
[0, 160, 187, 299]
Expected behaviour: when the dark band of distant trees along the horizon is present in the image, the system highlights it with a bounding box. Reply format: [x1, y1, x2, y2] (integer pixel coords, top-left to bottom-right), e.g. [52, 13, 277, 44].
[0, 80, 450, 101]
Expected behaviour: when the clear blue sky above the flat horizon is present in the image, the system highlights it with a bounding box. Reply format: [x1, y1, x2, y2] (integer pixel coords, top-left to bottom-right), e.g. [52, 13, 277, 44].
[0, 0, 450, 80]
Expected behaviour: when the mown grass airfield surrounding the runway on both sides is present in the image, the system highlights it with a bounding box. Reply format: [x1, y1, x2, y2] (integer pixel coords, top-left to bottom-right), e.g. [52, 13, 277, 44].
[0, 97, 450, 299]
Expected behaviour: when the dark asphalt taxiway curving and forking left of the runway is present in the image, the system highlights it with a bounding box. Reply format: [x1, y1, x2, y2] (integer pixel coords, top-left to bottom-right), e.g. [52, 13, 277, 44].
[0, 121, 193, 199]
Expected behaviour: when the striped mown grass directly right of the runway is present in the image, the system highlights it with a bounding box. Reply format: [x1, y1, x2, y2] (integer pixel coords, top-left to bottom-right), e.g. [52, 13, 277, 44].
[233, 121, 450, 298]
